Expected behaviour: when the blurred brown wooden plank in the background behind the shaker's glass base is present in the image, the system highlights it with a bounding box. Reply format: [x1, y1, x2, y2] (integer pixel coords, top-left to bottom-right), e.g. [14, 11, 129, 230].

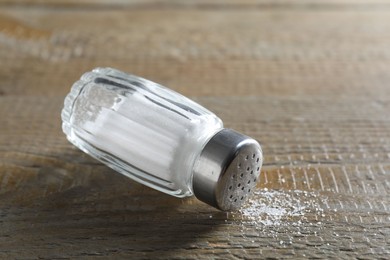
[0, 3, 390, 98]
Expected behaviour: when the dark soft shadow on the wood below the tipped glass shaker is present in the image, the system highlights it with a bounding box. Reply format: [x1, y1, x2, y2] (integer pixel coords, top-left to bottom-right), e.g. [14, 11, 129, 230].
[0, 160, 227, 258]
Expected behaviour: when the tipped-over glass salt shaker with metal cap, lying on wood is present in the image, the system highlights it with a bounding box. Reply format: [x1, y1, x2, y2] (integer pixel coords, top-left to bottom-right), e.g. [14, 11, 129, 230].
[61, 68, 263, 211]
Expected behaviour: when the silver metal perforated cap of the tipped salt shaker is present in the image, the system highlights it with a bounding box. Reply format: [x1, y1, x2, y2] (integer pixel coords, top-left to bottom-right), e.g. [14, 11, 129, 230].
[193, 129, 263, 211]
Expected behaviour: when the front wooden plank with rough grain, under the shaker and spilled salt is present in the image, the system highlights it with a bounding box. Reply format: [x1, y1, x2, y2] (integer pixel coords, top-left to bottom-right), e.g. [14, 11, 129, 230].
[0, 97, 390, 259]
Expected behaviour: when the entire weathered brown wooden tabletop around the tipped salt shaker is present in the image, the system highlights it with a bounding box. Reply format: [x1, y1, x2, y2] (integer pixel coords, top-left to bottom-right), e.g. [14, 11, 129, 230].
[0, 0, 390, 259]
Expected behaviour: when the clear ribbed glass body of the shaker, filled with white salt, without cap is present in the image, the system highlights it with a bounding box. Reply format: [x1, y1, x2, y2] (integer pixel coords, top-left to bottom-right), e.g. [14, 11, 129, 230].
[62, 68, 223, 197]
